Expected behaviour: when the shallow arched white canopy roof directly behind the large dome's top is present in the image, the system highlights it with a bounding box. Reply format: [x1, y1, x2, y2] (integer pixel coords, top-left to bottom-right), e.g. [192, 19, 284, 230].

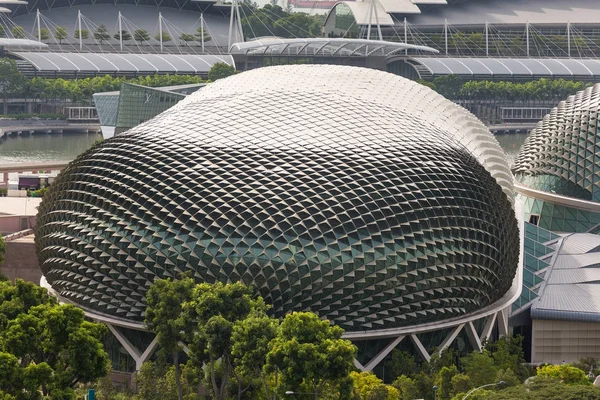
[231, 38, 438, 57]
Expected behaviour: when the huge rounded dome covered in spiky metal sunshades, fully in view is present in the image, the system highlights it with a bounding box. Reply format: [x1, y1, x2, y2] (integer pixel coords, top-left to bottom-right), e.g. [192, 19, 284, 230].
[36, 65, 519, 331]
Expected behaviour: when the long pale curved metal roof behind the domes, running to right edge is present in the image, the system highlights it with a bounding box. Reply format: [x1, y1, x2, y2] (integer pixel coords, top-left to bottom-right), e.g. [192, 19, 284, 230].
[408, 57, 600, 78]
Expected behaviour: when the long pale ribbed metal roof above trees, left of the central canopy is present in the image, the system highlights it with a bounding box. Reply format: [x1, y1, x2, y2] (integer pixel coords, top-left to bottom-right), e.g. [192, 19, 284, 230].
[12, 52, 235, 74]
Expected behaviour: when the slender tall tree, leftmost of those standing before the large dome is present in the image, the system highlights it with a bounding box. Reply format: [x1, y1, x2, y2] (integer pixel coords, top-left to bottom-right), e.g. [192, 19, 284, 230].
[146, 278, 194, 400]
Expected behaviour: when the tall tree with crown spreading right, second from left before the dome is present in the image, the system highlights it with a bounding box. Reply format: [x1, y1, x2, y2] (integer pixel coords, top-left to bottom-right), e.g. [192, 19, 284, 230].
[184, 283, 267, 400]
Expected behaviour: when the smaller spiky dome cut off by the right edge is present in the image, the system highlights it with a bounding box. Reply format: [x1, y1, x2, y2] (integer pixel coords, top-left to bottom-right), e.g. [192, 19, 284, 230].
[513, 84, 600, 201]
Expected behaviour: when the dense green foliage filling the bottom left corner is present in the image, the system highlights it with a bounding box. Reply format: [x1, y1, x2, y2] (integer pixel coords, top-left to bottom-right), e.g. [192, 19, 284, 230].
[0, 279, 110, 399]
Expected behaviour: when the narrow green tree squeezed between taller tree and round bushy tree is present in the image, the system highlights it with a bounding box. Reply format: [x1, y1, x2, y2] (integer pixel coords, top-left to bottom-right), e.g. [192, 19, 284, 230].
[231, 313, 279, 399]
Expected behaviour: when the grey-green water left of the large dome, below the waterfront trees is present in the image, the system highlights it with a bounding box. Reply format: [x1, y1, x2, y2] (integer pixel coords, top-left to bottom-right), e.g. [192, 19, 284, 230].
[0, 134, 102, 164]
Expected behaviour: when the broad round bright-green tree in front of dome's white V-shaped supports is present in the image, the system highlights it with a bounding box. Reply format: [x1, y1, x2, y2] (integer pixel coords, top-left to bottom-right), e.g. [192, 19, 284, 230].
[265, 312, 357, 399]
